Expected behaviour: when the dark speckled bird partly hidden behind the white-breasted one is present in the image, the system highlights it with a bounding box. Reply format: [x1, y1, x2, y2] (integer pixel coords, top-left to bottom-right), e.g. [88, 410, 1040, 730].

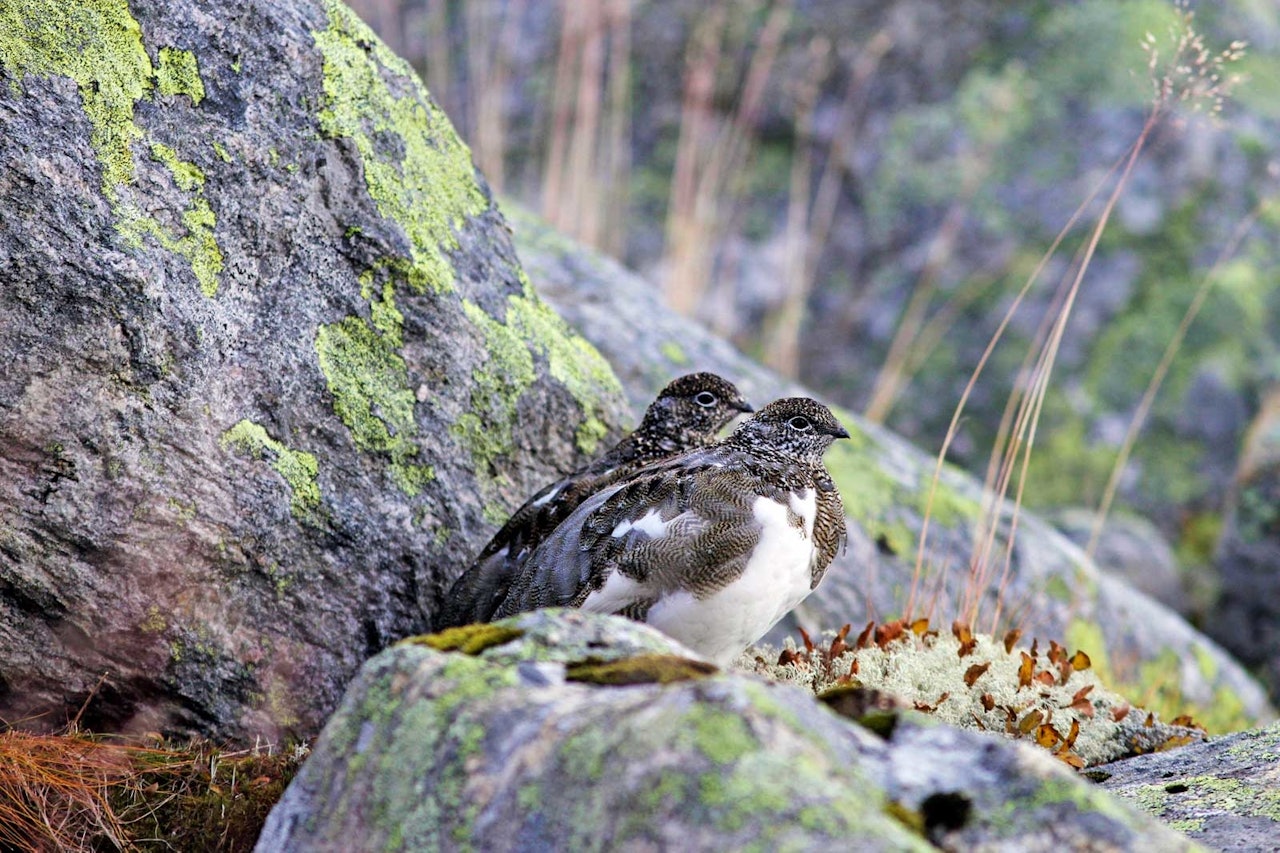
[434, 373, 754, 630]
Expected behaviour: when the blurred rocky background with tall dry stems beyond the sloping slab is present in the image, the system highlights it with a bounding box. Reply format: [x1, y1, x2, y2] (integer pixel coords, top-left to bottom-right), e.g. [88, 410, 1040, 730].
[352, 0, 1280, 694]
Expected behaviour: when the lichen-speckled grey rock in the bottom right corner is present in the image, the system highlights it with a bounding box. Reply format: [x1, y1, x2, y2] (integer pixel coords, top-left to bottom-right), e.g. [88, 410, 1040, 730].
[1087, 724, 1280, 850]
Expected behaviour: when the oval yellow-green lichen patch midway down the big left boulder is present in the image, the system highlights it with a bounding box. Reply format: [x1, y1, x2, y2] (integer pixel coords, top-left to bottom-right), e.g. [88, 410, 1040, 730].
[315, 316, 435, 497]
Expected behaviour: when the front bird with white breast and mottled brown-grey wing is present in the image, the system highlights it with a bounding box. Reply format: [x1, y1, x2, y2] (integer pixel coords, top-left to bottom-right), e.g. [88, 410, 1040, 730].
[494, 397, 849, 666]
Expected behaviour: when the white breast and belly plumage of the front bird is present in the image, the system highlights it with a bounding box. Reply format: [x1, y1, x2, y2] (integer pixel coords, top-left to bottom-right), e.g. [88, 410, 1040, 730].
[645, 489, 818, 666]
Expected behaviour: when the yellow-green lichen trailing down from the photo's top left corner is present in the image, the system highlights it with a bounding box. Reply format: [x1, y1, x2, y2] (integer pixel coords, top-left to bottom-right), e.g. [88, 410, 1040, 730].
[0, 0, 223, 296]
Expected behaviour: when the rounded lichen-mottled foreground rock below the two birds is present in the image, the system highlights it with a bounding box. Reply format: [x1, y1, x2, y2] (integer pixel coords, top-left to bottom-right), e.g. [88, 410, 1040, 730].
[257, 611, 1190, 853]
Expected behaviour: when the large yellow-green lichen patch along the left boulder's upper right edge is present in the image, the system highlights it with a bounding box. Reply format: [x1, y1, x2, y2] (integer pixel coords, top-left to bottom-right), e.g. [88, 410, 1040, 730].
[312, 0, 489, 291]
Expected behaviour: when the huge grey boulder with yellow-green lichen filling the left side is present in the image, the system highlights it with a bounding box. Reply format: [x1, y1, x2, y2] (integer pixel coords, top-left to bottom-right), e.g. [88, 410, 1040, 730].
[0, 0, 630, 739]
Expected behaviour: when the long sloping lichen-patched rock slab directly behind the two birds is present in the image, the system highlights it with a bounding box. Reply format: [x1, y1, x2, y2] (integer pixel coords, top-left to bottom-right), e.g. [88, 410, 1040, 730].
[514, 205, 1274, 731]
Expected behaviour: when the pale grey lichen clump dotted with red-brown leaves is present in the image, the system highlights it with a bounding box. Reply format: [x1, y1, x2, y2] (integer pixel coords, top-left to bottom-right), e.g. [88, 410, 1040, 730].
[737, 630, 1203, 765]
